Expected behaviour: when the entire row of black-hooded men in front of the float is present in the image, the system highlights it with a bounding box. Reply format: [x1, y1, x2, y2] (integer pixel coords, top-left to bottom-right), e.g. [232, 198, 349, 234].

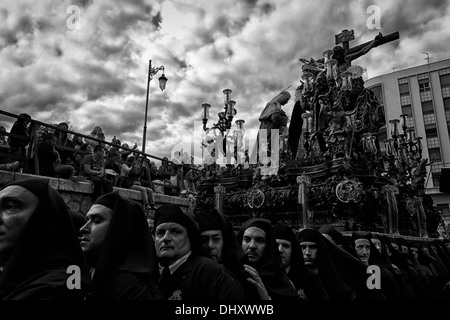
[0, 178, 450, 301]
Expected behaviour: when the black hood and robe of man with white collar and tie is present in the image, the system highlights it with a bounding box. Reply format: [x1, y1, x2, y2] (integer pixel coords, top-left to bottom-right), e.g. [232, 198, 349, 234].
[155, 205, 246, 301]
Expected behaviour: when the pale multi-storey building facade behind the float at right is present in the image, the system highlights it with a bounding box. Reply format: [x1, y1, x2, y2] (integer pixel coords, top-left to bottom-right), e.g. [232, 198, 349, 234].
[365, 59, 450, 225]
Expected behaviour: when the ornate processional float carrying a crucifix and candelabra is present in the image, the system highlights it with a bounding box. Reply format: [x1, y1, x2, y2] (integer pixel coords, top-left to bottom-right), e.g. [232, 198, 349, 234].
[193, 30, 443, 238]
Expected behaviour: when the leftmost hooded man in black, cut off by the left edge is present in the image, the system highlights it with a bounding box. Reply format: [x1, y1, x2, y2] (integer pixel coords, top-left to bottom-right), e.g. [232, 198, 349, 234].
[0, 178, 91, 301]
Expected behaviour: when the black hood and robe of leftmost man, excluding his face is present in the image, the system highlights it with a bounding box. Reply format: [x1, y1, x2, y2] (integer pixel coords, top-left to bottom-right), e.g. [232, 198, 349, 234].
[0, 178, 91, 300]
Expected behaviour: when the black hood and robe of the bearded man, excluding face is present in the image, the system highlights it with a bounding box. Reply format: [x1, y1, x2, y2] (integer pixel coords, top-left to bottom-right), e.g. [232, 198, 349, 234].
[237, 218, 299, 300]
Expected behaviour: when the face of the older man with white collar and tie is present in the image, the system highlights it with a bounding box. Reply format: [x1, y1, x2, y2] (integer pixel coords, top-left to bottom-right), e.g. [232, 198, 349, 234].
[155, 222, 191, 266]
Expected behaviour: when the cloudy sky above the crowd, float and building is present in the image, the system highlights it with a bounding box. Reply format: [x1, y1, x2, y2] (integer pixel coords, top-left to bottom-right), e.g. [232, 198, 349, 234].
[0, 0, 450, 164]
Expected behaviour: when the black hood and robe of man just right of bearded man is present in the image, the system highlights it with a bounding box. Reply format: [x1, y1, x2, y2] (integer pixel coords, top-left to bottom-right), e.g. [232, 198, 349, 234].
[273, 223, 329, 301]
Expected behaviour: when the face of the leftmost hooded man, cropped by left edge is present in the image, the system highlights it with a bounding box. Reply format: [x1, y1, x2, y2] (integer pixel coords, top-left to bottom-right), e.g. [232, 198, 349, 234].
[0, 186, 39, 262]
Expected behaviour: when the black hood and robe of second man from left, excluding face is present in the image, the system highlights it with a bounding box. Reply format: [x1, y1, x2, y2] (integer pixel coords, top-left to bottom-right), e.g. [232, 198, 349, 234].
[81, 191, 162, 300]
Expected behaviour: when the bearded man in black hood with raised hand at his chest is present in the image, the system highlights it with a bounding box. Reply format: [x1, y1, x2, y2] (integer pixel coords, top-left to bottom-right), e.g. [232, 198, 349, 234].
[237, 218, 300, 301]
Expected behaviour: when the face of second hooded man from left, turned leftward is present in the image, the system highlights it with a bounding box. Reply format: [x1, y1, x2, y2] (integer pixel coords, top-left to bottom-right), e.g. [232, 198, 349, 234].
[80, 204, 112, 257]
